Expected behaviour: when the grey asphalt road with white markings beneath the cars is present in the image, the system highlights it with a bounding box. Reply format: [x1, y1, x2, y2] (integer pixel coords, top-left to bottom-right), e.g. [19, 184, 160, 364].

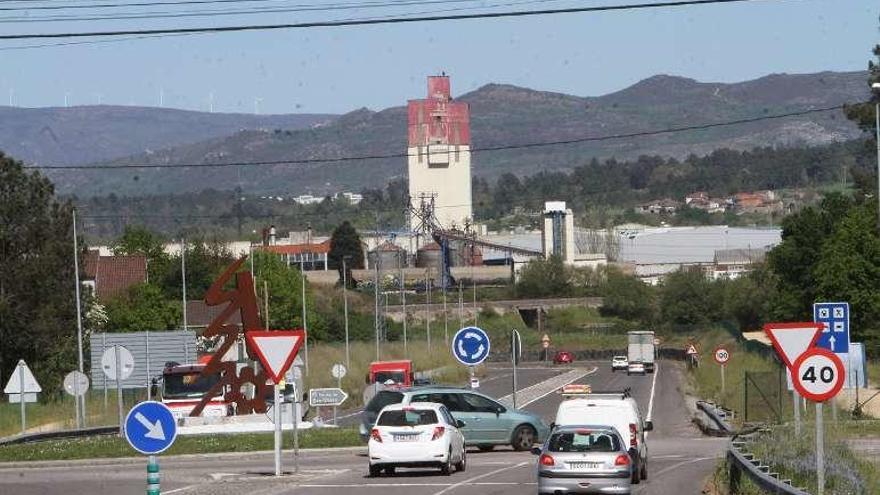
[0, 363, 724, 495]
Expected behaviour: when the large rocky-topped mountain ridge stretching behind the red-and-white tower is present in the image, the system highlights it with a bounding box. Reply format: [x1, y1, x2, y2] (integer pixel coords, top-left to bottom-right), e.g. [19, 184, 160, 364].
[31, 72, 868, 198]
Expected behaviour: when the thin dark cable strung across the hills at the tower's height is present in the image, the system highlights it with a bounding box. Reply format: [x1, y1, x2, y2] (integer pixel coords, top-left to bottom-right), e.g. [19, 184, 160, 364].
[24, 105, 843, 170]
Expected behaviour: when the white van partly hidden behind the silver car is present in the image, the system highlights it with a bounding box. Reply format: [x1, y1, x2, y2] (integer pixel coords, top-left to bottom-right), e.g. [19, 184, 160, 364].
[551, 392, 654, 483]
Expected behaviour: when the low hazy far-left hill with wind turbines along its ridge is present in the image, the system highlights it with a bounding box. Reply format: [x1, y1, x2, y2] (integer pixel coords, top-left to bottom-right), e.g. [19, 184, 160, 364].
[0, 105, 335, 165]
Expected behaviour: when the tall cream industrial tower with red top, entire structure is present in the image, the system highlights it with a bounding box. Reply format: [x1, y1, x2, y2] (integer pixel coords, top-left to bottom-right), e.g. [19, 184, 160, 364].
[407, 75, 473, 231]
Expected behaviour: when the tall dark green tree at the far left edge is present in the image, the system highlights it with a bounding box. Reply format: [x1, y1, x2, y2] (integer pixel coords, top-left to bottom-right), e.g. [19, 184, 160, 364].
[0, 153, 82, 398]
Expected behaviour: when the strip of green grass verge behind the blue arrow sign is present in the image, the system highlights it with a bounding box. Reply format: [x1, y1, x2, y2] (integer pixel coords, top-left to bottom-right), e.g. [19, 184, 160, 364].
[0, 428, 363, 462]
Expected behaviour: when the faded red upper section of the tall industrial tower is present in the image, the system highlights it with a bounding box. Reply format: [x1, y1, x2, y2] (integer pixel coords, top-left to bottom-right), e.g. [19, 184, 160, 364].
[408, 75, 471, 146]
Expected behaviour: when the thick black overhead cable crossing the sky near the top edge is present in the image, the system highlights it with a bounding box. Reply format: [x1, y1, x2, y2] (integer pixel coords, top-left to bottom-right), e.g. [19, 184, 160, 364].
[0, 0, 782, 40]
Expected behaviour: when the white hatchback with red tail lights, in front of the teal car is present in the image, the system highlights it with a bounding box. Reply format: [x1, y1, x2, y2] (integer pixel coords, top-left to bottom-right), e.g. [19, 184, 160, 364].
[367, 402, 467, 476]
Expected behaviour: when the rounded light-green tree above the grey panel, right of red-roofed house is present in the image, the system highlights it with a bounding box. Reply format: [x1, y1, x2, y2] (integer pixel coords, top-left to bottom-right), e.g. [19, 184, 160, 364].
[104, 283, 182, 332]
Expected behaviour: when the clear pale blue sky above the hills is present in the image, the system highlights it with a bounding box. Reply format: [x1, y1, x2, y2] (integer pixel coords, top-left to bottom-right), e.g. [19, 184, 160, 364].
[0, 0, 880, 114]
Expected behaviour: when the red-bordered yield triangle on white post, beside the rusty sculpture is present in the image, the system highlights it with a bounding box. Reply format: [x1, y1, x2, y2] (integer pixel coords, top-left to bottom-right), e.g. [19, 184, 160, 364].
[245, 329, 308, 476]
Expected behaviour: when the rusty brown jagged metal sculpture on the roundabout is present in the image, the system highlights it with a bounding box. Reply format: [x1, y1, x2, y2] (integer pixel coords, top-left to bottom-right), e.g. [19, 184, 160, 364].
[190, 256, 271, 416]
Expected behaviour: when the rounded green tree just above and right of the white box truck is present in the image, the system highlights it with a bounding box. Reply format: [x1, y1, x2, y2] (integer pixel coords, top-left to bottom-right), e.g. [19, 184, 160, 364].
[660, 270, 719, 326]
